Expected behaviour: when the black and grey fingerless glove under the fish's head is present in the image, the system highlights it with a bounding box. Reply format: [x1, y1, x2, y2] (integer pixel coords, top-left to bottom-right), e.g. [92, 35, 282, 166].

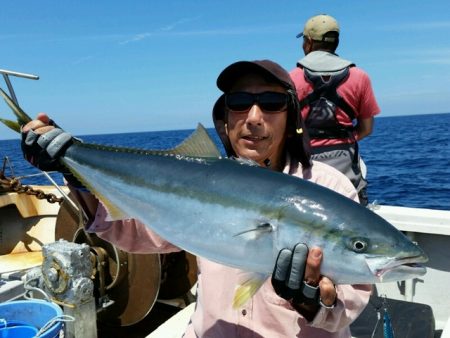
[272, 243, 320, 305]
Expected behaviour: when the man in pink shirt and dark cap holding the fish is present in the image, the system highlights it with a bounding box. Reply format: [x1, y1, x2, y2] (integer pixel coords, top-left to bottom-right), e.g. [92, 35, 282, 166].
[22, 60, 371, 338]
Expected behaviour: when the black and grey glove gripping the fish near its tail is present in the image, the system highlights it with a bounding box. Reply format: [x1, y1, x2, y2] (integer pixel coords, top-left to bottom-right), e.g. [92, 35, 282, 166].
[21, 121, 84, 189]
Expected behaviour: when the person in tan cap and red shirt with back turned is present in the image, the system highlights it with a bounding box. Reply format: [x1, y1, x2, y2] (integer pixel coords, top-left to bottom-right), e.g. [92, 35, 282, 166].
[290, 14, 380, 205]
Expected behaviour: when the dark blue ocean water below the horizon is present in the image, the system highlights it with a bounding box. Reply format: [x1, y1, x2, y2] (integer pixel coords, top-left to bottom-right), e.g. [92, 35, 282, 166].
[0, 113, 450, 210]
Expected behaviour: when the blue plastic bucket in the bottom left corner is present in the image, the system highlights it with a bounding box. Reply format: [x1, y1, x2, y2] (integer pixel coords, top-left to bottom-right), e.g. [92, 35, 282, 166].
[0, 299, 63, 338]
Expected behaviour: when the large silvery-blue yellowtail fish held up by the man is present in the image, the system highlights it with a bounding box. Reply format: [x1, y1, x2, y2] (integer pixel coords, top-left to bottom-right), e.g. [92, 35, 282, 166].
[2, 88, 427, 308]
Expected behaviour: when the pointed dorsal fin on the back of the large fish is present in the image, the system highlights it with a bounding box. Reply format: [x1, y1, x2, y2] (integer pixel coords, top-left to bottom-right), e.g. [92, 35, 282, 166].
[169, 123, 220, 158]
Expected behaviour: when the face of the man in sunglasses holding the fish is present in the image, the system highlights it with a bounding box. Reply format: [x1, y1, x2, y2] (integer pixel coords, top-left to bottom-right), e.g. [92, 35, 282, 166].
[226, 74, 287, 169]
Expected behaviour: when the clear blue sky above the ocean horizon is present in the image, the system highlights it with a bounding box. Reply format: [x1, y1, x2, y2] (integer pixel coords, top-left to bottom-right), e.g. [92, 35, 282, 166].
[0, 0, 450, 139]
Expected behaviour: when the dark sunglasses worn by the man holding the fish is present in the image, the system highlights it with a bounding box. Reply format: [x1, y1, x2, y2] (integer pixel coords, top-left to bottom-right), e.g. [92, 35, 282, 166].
[225, 92, 288, 113]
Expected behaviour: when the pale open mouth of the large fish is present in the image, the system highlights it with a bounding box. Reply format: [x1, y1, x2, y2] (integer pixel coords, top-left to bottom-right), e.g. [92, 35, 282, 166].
[366, 255, 428, 283]
